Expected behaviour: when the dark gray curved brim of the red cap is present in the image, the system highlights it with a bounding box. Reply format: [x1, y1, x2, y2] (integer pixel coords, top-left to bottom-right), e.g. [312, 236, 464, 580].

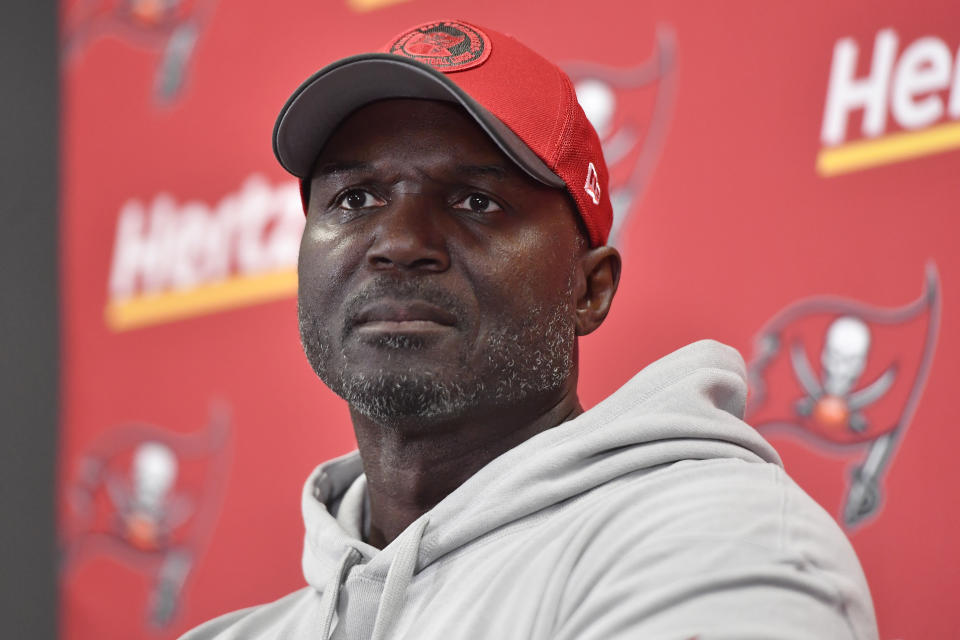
[273, 53, 566, 188]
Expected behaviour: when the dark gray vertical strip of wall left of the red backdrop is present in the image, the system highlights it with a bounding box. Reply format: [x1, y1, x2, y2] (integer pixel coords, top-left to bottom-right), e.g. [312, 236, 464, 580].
[0, 1, 59, 639]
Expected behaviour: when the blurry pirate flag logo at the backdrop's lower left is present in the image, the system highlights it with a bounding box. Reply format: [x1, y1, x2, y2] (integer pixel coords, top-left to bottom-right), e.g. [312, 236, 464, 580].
[61, 407, 230, 629]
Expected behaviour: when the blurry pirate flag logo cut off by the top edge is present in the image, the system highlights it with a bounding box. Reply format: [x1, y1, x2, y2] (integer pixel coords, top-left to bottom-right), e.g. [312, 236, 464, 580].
[63, 0, 216, 104]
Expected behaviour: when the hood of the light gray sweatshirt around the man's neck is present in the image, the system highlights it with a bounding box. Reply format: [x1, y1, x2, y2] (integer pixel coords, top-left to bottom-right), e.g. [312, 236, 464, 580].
[302, 340, 781, 638]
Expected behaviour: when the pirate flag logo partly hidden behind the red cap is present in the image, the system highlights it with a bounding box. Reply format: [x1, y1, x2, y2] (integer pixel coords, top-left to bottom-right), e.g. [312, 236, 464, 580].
[564, 28, 676, 245]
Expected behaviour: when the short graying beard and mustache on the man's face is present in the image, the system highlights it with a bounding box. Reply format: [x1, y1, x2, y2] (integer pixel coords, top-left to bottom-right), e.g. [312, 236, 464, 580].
[298, 275, 576, 423]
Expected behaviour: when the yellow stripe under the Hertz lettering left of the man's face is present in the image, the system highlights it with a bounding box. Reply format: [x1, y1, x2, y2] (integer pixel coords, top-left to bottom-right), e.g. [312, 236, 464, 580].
[104, 269, 297, 331]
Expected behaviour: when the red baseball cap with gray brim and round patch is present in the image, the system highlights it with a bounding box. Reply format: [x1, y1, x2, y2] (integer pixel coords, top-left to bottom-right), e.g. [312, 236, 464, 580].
[273, 20, 613, 247]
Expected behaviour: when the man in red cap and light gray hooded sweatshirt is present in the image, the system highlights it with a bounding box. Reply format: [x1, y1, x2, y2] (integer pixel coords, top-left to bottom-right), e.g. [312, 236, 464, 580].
[180, 20, 876, 640]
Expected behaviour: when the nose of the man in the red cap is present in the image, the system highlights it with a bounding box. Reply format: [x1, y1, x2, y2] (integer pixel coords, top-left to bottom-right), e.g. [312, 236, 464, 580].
[367, 193, 450, 273]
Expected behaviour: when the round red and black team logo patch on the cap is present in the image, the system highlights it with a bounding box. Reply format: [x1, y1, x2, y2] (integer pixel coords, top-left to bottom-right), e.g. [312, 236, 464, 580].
[387, 20, 490, 73]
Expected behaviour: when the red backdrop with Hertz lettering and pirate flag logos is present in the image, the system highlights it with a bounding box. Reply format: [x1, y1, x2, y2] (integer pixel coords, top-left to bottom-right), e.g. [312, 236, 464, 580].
[59, 0, 960, 640]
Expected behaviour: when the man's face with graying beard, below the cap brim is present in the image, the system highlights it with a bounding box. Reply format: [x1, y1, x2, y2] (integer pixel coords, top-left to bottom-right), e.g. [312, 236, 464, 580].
[299, 100, 586, 423]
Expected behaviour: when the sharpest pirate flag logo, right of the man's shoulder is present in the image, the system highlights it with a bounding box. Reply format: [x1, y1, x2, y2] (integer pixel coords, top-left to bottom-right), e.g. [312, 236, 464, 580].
[747, 264, 940, 529]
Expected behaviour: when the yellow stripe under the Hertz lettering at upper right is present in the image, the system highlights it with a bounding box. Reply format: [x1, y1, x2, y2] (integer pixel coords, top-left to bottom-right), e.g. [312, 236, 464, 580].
[817, 122, 960, 176]
